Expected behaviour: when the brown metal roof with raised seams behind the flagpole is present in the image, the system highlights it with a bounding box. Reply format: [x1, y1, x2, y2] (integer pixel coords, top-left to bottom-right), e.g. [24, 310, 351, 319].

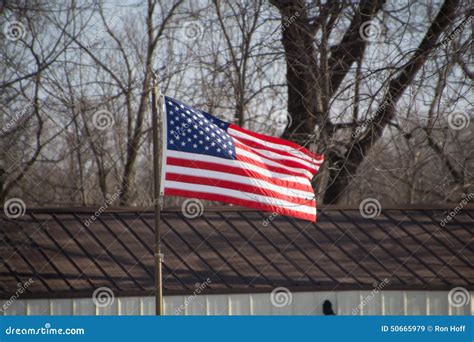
[0, 205, 474, 298]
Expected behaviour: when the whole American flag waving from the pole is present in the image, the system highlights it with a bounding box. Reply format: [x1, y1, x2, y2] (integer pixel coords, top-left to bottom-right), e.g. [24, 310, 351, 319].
[161, 96, 323, 222]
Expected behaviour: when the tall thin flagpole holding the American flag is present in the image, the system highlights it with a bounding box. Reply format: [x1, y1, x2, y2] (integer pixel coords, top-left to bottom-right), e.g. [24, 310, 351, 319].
[151, 72, 163, 316]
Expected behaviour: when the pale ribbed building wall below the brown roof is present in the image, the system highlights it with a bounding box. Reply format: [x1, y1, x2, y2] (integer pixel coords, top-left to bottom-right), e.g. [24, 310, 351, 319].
[0, 291, 474, 315]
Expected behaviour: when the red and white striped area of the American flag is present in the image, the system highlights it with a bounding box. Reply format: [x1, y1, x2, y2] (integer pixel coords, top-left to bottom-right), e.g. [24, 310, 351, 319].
[161, 124, 324, 222]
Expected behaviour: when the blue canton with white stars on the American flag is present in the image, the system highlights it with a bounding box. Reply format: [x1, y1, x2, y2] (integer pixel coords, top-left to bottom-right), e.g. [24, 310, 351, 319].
[165, 96, 235, 159]
